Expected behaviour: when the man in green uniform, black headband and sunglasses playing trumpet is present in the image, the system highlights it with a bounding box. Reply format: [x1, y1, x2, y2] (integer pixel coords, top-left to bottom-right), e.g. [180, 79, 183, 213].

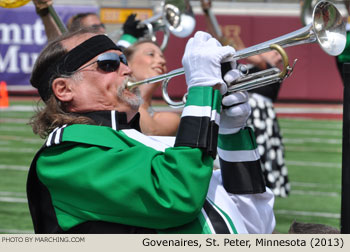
[27, 29, 275, 234]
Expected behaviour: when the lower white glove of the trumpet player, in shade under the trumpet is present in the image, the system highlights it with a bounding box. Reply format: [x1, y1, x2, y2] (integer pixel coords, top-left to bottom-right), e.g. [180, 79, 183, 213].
[219, 91, 251, 134]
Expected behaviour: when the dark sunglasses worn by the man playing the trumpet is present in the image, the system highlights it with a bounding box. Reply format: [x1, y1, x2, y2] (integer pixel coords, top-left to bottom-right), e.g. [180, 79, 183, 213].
[73, 52, 128, 73]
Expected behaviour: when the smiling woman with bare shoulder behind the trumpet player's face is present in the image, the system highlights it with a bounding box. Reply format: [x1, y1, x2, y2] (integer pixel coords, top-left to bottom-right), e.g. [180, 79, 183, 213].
[124, 40, 180, 136]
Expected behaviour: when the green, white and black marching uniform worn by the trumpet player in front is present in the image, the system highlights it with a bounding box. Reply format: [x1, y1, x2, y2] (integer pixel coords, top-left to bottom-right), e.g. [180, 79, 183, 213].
[27, 87, 274, 233]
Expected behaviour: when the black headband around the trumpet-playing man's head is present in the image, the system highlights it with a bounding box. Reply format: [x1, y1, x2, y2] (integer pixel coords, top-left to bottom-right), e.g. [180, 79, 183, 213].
[30, 35, 121, 101]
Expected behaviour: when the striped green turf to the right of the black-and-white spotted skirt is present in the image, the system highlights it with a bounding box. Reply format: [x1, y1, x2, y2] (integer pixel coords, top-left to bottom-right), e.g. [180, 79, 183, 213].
[275, 119, 342, 233]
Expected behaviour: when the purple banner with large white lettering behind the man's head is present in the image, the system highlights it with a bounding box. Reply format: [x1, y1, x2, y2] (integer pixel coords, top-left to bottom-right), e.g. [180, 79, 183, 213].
[0, 4, 98, 91]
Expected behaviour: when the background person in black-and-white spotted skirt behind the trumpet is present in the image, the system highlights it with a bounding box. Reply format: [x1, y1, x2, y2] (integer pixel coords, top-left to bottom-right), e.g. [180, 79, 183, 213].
[201, 0, 290, 197]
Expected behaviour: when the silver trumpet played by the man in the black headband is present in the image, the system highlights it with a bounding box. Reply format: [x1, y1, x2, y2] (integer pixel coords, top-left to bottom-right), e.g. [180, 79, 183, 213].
[127, 1, 346, 108]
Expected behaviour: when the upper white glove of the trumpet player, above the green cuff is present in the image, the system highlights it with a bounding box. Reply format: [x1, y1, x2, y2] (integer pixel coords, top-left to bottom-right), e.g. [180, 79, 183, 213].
[182, 31, 235, 94]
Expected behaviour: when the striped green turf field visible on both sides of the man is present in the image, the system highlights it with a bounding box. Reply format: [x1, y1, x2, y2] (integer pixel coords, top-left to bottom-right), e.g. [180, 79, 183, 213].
[0, 101, 342, 233]
